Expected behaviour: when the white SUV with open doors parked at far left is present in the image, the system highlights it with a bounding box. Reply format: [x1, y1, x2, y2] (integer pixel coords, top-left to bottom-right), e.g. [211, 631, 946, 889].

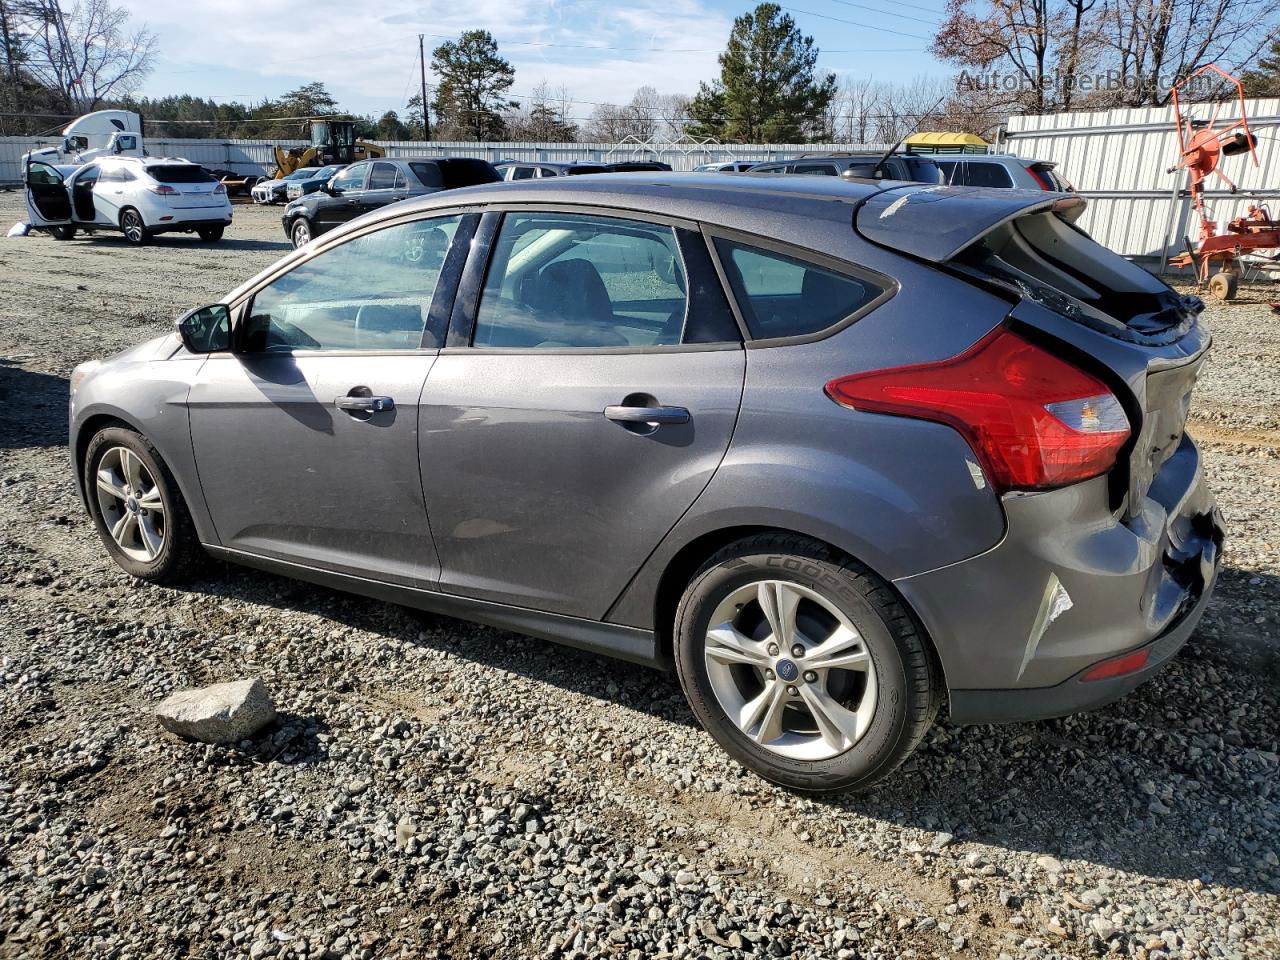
[26, 156, 232, 246]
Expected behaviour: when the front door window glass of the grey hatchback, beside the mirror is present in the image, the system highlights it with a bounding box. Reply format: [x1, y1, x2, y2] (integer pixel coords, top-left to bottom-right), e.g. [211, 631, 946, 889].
[238, 216, 462, 353]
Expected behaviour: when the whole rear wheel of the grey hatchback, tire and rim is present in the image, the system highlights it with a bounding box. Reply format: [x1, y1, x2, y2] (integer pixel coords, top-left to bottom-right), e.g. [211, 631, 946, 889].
[675, 534, 941, 792]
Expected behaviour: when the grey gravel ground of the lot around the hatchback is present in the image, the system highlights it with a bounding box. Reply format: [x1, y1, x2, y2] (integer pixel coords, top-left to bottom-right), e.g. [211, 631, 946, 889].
[0, 195, 1280, 960]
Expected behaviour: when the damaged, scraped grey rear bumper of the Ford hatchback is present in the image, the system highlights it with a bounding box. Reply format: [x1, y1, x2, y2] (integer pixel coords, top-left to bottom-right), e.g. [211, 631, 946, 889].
[896, 436, 1222, 723]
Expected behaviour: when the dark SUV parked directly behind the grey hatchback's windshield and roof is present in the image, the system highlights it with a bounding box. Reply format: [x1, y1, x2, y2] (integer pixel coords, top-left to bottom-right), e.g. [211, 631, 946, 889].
[280, 157, 502, 247]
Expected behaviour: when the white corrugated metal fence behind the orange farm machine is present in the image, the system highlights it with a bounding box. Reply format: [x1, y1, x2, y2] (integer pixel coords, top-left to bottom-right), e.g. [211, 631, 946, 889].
[1004, 97, 1280, 261]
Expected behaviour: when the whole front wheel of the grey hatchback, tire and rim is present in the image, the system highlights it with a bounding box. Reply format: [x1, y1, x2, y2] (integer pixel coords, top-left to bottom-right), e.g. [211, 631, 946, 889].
[83, 426, 205, 584]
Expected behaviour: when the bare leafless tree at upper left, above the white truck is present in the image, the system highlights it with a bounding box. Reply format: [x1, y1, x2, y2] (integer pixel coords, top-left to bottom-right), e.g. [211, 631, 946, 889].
[26, 0, 156, 113]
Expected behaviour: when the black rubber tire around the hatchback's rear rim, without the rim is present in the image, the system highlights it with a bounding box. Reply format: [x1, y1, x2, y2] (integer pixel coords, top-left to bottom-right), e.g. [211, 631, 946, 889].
[675, 554, 911, 791]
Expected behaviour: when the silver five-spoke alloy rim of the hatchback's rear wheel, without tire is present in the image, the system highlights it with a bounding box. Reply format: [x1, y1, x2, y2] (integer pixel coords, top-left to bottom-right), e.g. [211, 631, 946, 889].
[704, 580, 877, 760]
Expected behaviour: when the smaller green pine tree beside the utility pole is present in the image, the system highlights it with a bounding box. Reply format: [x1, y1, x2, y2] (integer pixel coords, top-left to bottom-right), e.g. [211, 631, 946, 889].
[431, 29, 516, 140]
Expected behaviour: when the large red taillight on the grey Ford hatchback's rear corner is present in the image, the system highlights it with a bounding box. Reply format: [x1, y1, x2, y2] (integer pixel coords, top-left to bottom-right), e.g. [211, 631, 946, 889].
[827, 328, 1129, 490]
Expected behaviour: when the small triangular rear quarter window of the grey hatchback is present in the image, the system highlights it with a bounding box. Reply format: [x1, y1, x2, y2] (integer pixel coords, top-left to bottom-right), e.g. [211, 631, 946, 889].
[716, 238, 886, 340]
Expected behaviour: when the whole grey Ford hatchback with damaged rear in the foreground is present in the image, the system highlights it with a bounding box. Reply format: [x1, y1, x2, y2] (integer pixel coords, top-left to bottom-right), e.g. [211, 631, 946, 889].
[69, 171, 1222, 791]
